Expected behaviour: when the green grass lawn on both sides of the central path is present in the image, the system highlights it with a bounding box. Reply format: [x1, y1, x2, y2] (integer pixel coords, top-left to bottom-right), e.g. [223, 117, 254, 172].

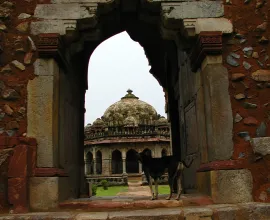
[96, 186, 170, 196]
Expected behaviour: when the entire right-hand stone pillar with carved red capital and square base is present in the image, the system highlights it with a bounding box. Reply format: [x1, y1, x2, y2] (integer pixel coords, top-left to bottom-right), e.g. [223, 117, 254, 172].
[191, 32, 253, 203]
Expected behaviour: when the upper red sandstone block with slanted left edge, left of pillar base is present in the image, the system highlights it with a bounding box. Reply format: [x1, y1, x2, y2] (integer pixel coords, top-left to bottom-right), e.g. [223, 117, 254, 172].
[8, 145, 28, 177]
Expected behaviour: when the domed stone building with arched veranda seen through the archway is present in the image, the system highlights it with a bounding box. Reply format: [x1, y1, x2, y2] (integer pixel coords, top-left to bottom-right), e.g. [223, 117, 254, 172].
[84, 90, 171, 185]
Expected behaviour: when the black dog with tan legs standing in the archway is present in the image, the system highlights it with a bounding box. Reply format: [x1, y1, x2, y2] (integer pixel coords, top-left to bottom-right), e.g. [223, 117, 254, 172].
[137, 150, 194, 200]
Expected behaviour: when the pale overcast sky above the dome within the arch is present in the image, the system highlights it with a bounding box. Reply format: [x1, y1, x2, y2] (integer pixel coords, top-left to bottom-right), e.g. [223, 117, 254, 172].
[85, 32, 166, 125]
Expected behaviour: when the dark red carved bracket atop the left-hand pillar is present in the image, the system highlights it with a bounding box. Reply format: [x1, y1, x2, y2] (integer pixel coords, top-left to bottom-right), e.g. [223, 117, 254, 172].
[37, 33, 70, 70]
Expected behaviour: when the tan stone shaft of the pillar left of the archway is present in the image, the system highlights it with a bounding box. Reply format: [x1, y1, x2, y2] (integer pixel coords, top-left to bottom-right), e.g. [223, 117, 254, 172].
[27, 59, 59, 167]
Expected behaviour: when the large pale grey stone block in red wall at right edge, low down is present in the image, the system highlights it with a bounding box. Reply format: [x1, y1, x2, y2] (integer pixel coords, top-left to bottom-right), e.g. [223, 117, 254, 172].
[251, 137, 270, 156]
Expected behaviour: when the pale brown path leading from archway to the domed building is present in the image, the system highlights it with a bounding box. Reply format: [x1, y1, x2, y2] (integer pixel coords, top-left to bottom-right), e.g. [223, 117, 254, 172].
[117, 182, 151, 196]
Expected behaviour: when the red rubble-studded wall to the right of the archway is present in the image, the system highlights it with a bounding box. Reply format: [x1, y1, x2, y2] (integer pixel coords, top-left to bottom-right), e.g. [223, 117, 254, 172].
[223, 0, 270, 202]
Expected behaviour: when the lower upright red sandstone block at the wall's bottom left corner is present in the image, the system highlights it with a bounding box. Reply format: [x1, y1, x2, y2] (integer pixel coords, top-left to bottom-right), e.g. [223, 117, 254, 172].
[8, 178, 28, 213]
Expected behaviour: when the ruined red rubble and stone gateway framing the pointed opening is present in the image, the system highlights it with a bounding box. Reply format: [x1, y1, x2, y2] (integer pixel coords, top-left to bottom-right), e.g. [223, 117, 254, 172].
[0, 0, 270, 219]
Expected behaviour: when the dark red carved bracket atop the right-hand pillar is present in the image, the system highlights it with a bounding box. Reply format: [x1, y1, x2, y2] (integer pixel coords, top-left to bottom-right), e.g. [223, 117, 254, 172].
[190, 31, 222, 72]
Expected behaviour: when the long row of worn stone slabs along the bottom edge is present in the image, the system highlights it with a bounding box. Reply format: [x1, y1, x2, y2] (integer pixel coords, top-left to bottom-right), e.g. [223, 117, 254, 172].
[0, 202, 270, 220]
